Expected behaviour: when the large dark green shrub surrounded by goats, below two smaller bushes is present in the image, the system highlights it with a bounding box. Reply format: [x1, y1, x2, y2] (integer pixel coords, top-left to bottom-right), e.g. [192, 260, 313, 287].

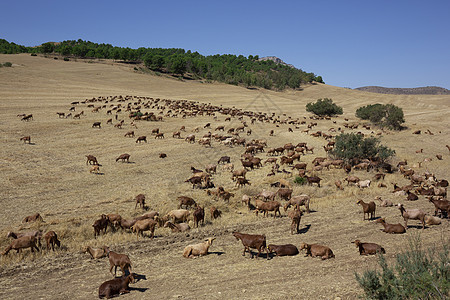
[330, 133, 395, 162]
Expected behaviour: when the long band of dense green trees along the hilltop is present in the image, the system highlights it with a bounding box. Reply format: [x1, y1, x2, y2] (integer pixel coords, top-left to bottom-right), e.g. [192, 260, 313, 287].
[0, 39, 323, 90]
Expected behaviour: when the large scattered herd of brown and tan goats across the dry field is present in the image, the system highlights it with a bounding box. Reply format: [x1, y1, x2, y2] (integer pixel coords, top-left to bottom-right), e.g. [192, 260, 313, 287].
[9, 96, 450, 298]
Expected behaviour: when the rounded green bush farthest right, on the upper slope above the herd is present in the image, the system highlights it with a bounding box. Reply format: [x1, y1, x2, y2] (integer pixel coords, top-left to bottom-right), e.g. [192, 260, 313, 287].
[355, 103, 405, 130]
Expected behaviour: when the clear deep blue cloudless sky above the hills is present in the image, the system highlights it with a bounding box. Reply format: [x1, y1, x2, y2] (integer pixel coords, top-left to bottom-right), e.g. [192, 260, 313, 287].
[0, 0, 450, 89]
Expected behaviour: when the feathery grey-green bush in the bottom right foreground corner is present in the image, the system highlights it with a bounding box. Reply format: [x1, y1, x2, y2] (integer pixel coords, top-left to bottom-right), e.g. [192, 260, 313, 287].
[355, 236, 450, 299]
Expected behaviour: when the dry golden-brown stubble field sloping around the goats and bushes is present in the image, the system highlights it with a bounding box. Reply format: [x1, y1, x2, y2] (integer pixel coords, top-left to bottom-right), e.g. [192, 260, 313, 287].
[0, 54, 450, 299]
